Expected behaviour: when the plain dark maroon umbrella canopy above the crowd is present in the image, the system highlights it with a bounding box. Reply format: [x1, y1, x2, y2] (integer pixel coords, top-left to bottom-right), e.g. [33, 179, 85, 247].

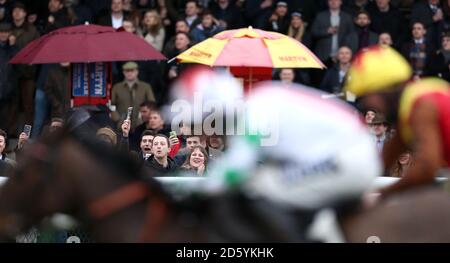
[10, 25, 166, 64]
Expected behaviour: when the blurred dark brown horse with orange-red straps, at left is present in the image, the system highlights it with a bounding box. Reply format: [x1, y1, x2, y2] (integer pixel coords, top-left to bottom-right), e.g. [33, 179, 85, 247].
[0, 114, 310, 242]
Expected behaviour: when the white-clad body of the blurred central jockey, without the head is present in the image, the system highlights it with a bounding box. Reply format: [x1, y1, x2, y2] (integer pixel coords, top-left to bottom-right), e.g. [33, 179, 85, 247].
[208, 82, 381, 211]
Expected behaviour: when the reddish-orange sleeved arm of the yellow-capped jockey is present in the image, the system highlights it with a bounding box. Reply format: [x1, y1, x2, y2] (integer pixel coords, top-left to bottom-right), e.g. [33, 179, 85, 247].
[381, 101, 443, 197]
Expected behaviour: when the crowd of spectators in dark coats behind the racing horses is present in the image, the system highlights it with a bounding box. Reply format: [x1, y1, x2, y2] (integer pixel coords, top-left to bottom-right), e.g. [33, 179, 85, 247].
[0, 0, 450, 176]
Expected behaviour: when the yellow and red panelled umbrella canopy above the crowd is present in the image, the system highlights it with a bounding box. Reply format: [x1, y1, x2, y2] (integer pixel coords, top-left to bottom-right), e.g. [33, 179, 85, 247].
[176, 27, 325, 68]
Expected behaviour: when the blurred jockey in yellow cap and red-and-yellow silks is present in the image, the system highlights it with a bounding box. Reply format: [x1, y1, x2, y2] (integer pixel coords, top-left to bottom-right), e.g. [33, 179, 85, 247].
[345, 45, 450, 203]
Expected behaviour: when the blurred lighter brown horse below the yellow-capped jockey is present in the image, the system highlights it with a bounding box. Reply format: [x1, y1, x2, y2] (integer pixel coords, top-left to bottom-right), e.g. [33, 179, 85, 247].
[341, 187, 450, 243]
